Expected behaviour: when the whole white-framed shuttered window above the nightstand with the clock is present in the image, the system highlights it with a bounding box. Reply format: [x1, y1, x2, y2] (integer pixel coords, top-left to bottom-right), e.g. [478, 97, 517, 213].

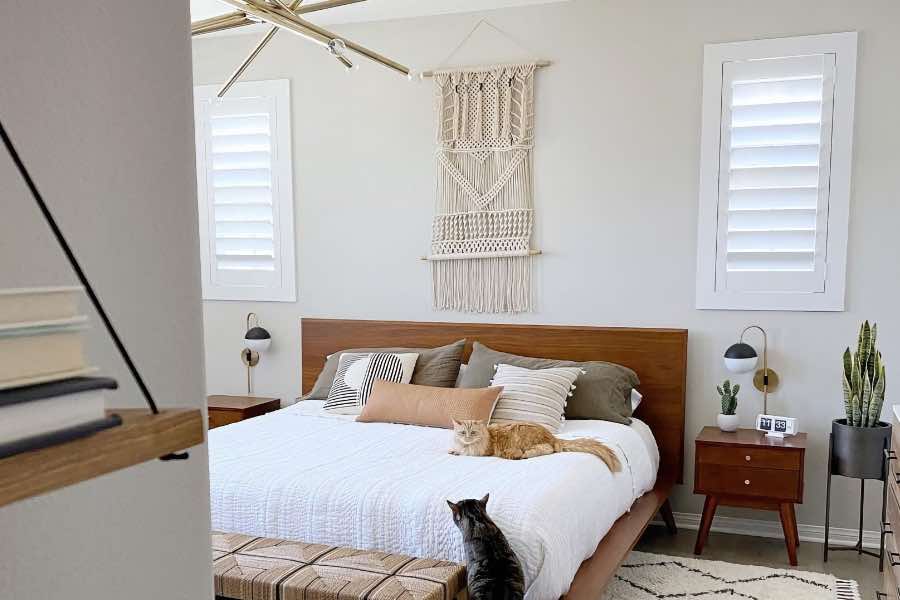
[697, 33, 857, 310]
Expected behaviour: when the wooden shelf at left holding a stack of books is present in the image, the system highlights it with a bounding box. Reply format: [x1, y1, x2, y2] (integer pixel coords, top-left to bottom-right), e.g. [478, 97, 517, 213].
[0, 409, 203, 506]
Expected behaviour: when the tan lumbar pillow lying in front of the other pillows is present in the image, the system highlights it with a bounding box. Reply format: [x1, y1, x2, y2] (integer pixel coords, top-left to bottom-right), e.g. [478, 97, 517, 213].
[356, 381, 503, 429]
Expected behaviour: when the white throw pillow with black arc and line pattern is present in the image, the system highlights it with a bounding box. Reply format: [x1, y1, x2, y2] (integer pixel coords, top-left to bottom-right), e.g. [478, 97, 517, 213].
[324, 352, 419, 415]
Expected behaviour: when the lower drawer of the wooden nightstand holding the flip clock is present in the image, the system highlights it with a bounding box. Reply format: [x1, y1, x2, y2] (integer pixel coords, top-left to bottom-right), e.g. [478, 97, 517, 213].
[694, 464, 803, 502]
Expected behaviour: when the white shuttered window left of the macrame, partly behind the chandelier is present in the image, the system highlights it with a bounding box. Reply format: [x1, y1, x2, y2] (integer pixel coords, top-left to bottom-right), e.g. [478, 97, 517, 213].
[194, 80, 297, 302]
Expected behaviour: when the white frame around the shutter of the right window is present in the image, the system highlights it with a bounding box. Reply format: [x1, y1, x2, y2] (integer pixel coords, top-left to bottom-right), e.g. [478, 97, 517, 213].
[696, 32, 857, 311]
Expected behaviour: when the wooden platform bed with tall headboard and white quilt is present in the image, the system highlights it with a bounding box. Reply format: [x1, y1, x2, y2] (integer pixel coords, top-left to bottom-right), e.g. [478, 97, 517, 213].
[209, 319, 687, 600]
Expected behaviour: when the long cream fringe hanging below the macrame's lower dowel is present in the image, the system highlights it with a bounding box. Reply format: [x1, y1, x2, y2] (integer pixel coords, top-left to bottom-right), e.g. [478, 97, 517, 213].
[431, 256, 534, 313]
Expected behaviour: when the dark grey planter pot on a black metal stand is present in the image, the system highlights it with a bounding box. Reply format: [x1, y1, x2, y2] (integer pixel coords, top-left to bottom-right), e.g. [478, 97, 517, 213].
[831, 419, 891, 479]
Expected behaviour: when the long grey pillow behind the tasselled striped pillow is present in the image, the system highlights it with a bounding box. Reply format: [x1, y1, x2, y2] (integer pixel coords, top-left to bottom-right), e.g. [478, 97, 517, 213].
[459, 342, 640, 425]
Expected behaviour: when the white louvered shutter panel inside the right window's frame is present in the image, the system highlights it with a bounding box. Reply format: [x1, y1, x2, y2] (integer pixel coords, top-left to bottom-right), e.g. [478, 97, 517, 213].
[716, 54, 834, 292]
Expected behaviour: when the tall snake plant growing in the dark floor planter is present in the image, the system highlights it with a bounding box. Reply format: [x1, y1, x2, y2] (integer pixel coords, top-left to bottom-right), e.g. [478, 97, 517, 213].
[843, 321, 885, 427]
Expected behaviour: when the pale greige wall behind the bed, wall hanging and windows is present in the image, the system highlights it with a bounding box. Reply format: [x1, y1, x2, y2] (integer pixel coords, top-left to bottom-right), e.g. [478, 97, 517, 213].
[194, 0, 900, 529]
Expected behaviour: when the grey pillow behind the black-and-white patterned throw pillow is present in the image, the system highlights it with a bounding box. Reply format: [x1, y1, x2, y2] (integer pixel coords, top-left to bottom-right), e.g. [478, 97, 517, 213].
[304, 340, 468, 400]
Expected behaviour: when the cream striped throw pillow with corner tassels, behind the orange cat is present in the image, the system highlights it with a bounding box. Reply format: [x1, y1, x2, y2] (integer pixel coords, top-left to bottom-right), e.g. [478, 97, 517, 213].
[491, 364, 582, 433]
